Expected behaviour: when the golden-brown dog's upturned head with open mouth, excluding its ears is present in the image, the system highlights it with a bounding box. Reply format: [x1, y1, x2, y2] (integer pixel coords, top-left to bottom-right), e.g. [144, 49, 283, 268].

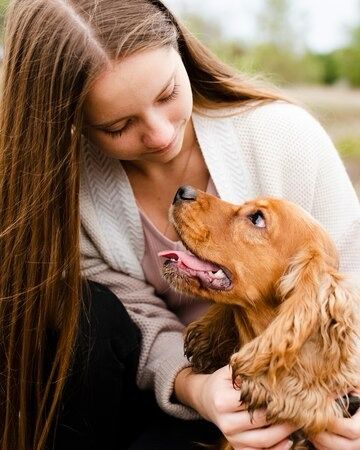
[159, 186, 338, 306]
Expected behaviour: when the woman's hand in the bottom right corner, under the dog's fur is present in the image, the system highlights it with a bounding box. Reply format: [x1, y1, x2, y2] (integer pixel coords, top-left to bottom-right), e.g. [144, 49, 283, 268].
[311, 398, 360, 450]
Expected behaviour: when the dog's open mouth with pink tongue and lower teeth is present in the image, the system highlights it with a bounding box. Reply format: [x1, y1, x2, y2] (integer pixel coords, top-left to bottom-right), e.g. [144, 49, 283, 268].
[158, 250, 231, 290]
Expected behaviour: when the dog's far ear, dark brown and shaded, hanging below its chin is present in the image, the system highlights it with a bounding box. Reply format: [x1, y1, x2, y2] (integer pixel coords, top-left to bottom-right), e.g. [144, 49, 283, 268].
[184, 304, 239, 373]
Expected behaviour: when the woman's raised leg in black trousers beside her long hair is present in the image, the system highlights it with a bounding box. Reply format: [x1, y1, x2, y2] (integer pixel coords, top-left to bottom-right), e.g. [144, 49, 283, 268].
[55, 282, 141, 450]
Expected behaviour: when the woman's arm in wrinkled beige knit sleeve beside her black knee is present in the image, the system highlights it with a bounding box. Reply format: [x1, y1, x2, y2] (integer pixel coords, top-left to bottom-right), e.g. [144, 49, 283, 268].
[81, 229, 199, 419]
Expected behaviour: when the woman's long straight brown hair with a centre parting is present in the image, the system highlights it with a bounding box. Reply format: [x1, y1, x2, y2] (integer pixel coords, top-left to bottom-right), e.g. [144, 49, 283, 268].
[0, 0, 286, 450]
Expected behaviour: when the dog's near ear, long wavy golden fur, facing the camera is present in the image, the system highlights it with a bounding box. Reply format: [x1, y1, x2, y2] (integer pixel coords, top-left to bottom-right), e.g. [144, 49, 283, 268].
[232, 247, 355, 383]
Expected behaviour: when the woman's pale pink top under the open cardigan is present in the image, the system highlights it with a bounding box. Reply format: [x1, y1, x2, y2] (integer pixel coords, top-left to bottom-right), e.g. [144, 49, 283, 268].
[139, 178, 218, 325]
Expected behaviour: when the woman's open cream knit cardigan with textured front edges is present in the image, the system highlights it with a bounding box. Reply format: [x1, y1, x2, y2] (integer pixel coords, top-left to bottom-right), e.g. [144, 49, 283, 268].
[80, 102, 360, 419]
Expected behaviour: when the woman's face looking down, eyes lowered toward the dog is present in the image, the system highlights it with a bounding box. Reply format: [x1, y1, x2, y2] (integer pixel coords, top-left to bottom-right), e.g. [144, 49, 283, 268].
[84, 47, 193, 162]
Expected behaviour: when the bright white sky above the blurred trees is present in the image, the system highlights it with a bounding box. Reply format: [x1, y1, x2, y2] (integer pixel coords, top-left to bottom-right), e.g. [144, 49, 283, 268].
[164, 0, 360, 52]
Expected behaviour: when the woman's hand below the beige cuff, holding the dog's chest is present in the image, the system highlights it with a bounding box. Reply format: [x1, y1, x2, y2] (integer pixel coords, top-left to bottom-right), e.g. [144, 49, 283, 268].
[175, 366, 295, 450]
